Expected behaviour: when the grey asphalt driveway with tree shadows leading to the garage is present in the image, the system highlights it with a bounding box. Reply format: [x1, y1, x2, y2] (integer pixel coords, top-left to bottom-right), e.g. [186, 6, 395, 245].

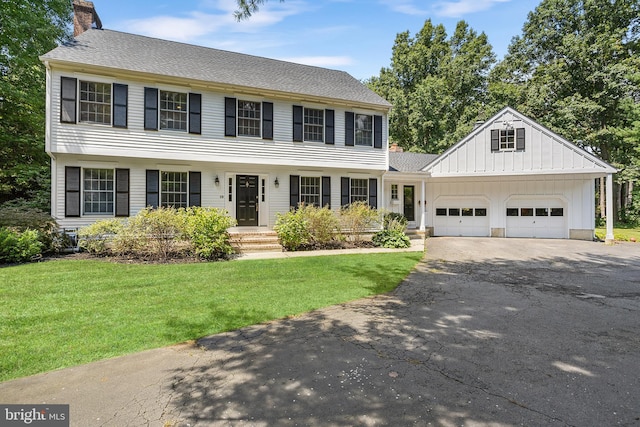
[0, 238, 640, 426]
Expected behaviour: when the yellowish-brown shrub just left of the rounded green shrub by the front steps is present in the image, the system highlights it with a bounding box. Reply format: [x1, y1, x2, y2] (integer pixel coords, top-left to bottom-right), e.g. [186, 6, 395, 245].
[113, 207, 186, 261]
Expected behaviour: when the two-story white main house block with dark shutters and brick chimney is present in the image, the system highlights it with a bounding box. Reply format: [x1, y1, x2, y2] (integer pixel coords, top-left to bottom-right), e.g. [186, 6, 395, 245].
[41, 0, 391, 234]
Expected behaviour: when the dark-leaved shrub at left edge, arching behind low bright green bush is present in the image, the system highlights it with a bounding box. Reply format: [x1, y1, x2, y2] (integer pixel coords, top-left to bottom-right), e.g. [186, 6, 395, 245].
[0, 200, 62, 253]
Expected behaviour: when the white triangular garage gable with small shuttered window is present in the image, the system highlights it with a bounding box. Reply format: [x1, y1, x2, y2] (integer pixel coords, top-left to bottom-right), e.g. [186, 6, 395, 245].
[423, 107, 616, 177]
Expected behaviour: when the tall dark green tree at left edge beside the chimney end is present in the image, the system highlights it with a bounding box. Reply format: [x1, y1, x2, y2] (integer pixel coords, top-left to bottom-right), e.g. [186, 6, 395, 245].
[0, 0, 72, 209]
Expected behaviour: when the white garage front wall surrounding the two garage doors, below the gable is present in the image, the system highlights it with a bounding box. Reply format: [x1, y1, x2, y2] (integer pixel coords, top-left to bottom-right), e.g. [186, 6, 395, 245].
[427, 175, 595, 237]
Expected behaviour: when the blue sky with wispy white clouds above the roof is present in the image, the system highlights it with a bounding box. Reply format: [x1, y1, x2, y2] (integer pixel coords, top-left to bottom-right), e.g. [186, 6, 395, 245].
[93, 0, 541, 80]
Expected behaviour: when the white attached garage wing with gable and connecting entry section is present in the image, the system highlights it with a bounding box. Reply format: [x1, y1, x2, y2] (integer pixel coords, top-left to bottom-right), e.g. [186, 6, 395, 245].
[383, 107, 616, 240]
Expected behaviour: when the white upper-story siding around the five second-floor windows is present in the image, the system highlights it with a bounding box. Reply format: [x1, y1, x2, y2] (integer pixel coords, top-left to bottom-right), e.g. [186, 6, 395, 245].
[48, 70, 388, 171]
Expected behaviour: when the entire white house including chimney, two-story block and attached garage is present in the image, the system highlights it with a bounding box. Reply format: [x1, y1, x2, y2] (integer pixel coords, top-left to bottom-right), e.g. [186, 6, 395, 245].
[41, 0, 615, 239]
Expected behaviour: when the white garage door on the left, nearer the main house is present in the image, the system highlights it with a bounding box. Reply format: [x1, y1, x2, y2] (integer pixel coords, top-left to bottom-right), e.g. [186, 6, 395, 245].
[433, 197, 490, 237]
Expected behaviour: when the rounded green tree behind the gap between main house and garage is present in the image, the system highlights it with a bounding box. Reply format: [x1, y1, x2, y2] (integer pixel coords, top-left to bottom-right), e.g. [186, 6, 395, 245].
[367, 20, 495, 153]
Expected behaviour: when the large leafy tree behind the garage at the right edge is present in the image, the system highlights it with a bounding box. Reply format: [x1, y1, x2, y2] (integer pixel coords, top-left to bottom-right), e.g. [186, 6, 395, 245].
[489, 0, 640, 224]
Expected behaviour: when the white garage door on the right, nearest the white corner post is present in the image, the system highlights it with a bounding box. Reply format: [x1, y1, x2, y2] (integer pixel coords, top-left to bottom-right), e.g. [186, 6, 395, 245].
[506, 198, 568, 239]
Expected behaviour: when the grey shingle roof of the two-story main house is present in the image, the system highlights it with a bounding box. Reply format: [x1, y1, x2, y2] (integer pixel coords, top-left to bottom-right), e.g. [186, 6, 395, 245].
[40, 29, 391, 108]
